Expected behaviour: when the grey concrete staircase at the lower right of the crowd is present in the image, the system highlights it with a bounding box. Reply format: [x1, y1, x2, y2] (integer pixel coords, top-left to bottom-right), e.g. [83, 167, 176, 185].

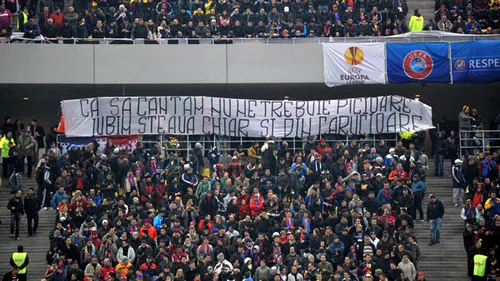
[415, 159, 470, 281]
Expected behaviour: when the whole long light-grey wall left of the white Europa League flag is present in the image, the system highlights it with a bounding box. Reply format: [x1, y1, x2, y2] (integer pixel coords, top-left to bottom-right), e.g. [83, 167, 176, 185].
[0, 44, 323, 84]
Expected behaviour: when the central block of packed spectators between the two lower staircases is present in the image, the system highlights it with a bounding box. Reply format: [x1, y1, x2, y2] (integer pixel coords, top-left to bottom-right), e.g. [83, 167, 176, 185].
[39, 134, 434, 280]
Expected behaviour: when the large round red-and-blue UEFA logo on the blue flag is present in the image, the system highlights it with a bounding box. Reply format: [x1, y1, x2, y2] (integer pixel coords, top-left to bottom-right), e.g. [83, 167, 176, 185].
[403, 50, 434, 80]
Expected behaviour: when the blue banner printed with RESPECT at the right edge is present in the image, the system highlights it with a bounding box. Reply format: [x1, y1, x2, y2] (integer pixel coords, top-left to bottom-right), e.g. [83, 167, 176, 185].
[451, 40, 500, 84]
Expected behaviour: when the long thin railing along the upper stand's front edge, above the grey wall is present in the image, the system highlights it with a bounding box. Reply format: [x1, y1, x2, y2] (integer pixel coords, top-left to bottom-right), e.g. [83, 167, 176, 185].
[0, 31, 500, 45]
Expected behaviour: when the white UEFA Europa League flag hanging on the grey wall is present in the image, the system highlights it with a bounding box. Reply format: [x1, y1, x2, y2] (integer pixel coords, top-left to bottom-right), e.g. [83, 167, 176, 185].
[323, 43, 387, 87]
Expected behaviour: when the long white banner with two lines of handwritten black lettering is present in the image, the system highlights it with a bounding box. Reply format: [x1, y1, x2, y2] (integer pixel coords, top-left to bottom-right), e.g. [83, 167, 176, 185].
[62, 96, 433, 138]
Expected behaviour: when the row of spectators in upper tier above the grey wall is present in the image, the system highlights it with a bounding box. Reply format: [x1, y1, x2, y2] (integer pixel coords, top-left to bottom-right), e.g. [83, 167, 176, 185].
[0, 0, 416, 39]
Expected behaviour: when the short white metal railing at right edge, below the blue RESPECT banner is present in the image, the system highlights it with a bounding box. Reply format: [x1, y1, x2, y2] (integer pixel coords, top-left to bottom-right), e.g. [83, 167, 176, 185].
[459, 130, 500, 156]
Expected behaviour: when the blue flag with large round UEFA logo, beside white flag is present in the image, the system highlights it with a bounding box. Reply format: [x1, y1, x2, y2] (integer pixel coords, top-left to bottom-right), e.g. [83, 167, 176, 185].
[387, 42, 451, 83]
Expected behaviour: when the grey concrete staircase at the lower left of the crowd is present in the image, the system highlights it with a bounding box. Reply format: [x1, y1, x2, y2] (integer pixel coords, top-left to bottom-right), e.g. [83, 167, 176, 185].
[0, 178, 55, 281]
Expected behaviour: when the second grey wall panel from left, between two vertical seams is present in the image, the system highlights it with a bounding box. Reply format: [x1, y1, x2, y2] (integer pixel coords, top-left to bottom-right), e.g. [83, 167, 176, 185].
[94, 45, 227, 84]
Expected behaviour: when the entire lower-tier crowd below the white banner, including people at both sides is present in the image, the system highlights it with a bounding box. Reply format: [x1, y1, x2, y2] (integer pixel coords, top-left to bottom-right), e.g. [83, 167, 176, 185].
[0, 110, 500, 281]
